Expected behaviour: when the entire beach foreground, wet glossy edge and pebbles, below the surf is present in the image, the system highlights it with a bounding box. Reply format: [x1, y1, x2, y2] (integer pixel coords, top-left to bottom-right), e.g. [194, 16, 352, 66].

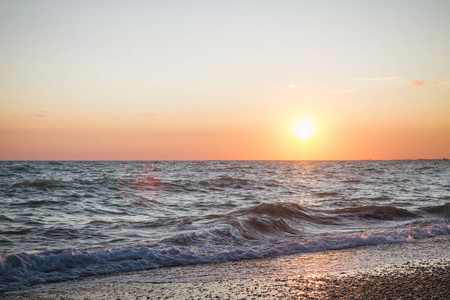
[1, 236, 450, 299]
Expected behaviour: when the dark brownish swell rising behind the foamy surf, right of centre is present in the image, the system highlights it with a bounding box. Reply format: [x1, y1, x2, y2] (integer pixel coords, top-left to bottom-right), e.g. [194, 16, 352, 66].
[211, 203, 432, 242]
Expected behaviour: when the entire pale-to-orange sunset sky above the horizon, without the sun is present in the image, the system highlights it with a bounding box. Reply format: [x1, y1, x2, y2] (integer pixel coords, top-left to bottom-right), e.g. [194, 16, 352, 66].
[0, 0, 450, 160]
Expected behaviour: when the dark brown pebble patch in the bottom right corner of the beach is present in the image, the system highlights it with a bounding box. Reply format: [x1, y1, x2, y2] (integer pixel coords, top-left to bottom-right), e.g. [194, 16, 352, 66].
[282, 261, 450, 299]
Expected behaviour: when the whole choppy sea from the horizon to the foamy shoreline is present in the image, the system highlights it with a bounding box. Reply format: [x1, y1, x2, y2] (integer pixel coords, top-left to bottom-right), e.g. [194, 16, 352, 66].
[0, 160, 450, 291]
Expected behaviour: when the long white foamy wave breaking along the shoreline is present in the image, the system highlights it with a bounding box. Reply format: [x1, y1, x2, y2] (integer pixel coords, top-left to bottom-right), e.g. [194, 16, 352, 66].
[0, 219, 450, 291]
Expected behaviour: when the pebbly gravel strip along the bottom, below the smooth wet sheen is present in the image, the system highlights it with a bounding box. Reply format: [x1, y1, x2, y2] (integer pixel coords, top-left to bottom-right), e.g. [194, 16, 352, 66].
[0, 260, 450, 299]
